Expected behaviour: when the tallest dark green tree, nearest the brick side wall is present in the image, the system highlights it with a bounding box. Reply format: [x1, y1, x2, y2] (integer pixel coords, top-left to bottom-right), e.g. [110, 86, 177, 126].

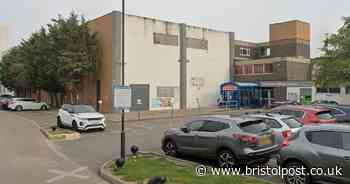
[48, 13, 99, 104]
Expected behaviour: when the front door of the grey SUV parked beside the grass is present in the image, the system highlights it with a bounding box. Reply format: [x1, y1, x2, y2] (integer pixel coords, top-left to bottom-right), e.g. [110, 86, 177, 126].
[176, 120, 204, 155]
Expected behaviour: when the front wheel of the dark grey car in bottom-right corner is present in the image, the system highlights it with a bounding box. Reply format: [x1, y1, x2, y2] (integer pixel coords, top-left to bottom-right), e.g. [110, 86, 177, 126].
[283, 162, 311, 184]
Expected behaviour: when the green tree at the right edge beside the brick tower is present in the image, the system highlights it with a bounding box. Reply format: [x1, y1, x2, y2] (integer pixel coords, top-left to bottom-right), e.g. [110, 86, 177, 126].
[316, 17, 350, 86]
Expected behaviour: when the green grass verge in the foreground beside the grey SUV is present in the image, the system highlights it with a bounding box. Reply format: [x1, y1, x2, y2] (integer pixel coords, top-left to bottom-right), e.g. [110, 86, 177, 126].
[110, 155, 268, 184]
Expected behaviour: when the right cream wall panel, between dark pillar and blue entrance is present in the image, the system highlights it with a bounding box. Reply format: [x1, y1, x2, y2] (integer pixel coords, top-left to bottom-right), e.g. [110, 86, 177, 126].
[187, 28, 230, 108]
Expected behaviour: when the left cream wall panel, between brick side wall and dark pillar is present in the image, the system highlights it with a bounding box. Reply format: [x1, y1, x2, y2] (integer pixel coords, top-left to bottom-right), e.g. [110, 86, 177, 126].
[125, 16, 180, 110]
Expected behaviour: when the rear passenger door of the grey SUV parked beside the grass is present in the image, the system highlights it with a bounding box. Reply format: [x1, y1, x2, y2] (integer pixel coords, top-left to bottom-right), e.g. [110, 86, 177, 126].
[193, 120, 229, 157]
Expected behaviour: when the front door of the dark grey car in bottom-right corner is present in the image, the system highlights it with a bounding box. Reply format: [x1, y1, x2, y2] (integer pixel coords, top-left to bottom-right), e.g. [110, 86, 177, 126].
[307, 131, 344, 182]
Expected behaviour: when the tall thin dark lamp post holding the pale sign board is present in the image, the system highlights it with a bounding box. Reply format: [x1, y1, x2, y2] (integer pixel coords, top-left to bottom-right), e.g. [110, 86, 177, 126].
[120, 0, 125, 159]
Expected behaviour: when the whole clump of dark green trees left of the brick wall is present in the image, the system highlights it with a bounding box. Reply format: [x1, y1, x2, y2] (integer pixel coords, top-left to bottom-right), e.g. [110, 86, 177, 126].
[0, 12, 99, 105]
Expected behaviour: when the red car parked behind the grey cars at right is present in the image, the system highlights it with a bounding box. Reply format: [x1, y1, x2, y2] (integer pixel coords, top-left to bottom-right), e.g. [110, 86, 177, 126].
[271, 105, 336, 125]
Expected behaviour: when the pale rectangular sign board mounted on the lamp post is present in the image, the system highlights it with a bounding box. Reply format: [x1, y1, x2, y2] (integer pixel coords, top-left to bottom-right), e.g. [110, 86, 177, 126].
[113, 86, 131, 109]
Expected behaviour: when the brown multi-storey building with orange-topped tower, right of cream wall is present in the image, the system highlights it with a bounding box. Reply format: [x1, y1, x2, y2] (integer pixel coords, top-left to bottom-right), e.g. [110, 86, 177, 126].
[232, 20, 315, 101]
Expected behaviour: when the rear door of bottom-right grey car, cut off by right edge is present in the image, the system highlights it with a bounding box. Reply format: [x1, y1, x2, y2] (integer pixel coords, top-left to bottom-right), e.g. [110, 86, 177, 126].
[340, 132, 350, 183]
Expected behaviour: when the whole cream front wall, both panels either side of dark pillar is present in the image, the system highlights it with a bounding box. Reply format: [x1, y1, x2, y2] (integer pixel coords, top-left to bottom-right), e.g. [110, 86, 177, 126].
[121, 15, 230, 110]
